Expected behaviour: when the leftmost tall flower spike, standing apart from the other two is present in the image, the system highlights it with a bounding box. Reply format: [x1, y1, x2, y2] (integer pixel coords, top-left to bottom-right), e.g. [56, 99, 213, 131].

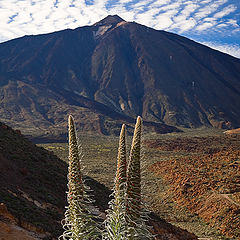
[59, 115, 100, 240]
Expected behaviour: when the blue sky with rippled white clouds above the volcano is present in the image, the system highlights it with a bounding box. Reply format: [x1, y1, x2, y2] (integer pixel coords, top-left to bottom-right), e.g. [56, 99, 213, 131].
[0, 0, 240, 58]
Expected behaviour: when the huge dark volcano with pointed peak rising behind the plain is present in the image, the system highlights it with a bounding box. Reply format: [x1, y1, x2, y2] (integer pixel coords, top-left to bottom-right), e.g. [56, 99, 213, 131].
[0, 16, 240, 137]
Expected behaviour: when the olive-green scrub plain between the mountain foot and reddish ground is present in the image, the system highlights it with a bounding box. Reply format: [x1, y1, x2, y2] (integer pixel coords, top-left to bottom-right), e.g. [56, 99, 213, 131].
[41, 128, 240, 240]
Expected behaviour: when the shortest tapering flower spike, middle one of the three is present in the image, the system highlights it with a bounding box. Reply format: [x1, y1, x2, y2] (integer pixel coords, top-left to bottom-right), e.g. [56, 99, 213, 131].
[103, 124, 127, 240]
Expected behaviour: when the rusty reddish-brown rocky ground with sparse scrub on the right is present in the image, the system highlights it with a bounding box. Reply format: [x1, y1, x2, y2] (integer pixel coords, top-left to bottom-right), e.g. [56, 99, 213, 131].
[146, 136, 240, 239]
